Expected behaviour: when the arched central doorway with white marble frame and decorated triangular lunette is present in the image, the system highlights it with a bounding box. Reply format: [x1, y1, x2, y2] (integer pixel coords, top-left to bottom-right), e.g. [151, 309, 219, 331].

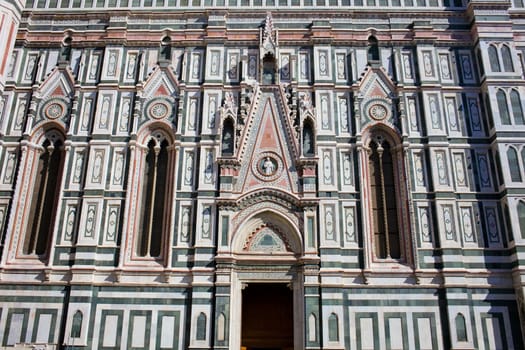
[231, 211, 304, 350]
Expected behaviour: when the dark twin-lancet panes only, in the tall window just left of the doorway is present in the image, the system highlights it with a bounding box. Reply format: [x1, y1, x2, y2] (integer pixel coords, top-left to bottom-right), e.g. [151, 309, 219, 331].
[136, 139, 168, 257]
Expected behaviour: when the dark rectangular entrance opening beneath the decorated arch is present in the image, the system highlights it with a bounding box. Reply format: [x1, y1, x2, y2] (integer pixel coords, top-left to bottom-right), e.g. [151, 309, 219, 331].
[241, 283, 293, 350]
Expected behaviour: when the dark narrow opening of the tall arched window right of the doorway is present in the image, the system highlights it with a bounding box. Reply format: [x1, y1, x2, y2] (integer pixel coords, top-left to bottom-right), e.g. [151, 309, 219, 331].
[368, 134, 401, 259]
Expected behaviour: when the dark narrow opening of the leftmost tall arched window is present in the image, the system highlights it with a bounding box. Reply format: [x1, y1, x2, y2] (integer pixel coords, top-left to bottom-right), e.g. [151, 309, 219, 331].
[22, 130, 65, 256]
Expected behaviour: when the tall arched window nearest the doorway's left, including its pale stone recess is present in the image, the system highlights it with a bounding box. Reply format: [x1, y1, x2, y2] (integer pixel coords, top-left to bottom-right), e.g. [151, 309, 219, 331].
[122, 126, 176, 265]
